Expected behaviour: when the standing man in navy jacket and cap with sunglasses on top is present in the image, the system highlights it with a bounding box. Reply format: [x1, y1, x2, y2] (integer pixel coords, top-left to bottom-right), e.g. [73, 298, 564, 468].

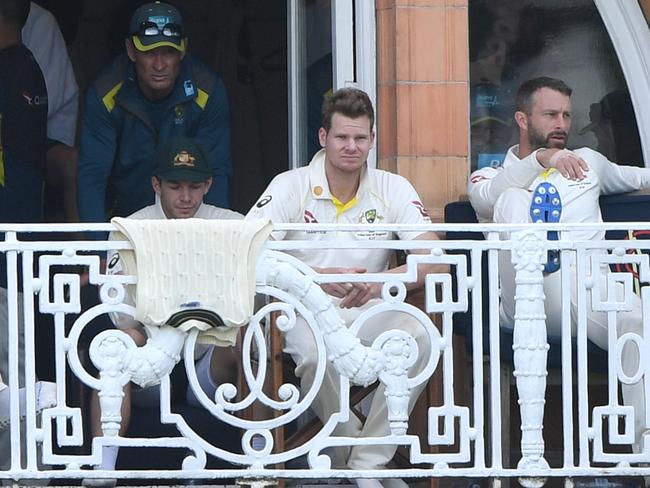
[77, 2, 232, 227]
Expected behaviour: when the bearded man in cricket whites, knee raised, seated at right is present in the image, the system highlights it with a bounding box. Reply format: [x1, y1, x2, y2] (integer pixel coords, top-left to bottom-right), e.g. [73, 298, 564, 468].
[468, 77, 650, 456]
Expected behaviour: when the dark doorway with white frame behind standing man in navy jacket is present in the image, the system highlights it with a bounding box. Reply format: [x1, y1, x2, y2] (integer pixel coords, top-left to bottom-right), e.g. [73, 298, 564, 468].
[57, 0, 375, 213]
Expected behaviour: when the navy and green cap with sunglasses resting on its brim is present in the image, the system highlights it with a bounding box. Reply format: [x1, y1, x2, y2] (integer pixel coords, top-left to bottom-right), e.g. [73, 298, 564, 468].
[129, 2, 186, 52]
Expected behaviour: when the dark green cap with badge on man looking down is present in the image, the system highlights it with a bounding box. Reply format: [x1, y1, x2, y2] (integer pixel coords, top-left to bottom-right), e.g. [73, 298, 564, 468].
[153, 137, 212, 181]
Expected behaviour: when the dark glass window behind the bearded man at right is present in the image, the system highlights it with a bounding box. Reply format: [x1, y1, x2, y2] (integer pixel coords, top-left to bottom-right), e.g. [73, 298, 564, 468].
[469, 0, 644, 170]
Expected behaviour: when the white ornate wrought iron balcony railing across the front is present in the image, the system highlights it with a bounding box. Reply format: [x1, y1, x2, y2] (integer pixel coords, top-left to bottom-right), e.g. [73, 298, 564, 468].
[0, 223, 650, 486]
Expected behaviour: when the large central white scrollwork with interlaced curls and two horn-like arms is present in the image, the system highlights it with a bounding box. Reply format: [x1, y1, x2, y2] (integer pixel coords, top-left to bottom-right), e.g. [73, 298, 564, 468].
[83, 248, 441, 468]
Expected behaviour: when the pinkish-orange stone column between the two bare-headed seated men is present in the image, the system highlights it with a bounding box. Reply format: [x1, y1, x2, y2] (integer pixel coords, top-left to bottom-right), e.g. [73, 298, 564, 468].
[377, 0, 469, 221]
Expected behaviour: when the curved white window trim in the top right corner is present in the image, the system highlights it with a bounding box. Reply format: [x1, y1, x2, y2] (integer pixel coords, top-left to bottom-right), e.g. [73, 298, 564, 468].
[594, 0, 650, 167]
